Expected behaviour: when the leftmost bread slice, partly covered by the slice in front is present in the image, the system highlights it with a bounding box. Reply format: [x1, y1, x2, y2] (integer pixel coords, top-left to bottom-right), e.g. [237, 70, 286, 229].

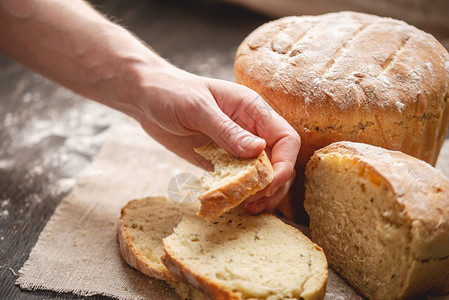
[117, 197, 198, 282]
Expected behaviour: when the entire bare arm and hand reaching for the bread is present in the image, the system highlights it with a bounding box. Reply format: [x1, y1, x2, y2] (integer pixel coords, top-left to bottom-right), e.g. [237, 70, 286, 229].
[0, 0, 300, 213]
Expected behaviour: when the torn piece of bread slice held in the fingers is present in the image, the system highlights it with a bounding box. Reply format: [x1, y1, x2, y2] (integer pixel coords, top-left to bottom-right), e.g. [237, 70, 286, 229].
[195, 143, 274, 222]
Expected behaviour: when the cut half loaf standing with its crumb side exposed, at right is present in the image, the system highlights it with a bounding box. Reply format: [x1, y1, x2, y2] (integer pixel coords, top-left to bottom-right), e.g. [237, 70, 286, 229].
[305, 142, 449, 299]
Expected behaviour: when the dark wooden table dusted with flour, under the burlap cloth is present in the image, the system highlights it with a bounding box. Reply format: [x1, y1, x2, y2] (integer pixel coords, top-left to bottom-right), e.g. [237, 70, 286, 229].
[0, 0, 267, 299]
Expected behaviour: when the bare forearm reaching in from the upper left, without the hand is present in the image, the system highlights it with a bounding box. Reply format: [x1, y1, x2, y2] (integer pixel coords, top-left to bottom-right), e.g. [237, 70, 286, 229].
[0, 0, 168, 118]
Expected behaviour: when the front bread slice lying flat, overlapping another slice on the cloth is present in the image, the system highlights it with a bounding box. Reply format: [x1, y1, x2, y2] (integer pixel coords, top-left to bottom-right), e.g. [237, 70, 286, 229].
[162, 207, 327, 300]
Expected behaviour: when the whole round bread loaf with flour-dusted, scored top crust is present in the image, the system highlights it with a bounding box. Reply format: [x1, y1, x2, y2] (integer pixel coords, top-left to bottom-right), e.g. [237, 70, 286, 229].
[234, 12, 449, 167]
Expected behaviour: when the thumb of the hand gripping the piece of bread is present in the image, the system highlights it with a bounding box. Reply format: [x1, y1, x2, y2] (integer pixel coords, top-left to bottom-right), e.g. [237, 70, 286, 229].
[202, 110, 266, 158]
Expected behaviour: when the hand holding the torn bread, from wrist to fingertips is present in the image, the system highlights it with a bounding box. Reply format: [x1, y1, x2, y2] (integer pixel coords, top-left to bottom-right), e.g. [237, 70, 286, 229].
[137, 66, 300, 214]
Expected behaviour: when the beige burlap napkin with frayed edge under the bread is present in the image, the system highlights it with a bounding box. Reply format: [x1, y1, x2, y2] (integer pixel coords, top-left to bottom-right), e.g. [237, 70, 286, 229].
[17, 116, 449, 300]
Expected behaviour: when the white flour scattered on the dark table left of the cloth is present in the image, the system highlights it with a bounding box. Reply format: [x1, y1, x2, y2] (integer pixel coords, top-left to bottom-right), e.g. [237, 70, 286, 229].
[0, 79, 121, 209]
